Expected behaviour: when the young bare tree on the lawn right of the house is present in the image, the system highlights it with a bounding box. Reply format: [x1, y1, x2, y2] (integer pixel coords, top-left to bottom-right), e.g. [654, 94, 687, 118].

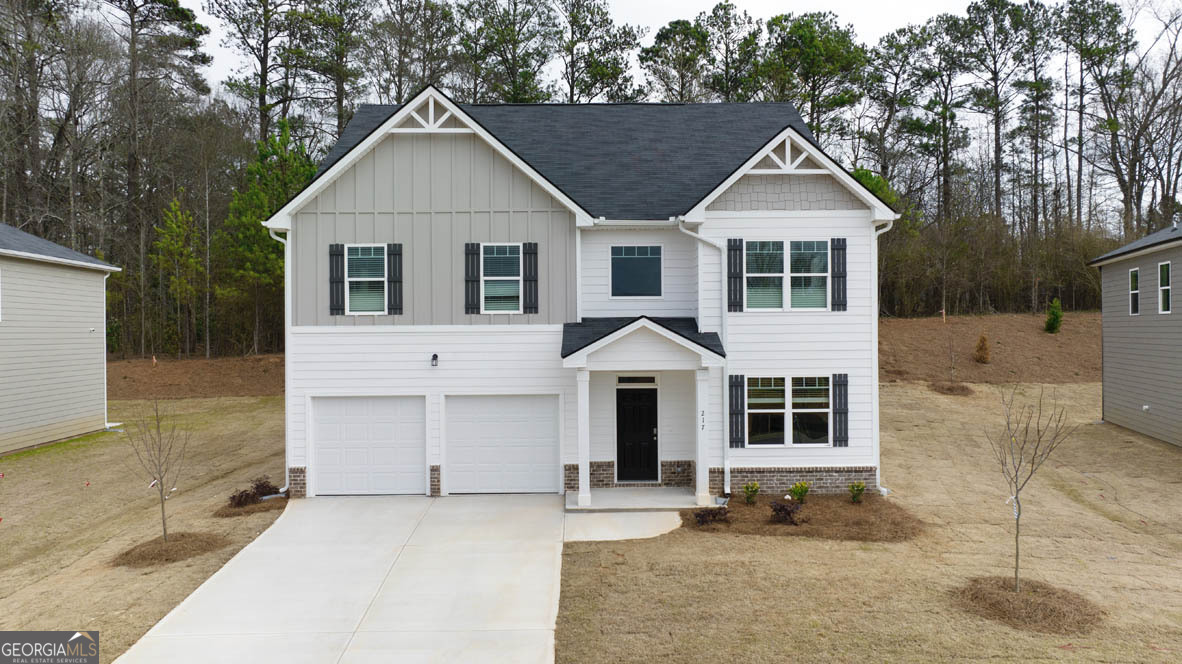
[985, 385, 1077, 592]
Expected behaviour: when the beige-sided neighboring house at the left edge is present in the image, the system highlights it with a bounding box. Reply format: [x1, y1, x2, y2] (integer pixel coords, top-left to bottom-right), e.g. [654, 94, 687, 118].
[0, 223, 119, 454]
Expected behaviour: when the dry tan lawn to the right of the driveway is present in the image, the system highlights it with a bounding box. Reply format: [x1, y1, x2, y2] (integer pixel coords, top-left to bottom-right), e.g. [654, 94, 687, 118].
[556, 382, 1182, 664]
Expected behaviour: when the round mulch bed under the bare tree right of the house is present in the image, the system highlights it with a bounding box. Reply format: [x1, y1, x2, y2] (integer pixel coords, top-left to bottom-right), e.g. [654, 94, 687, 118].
[953, 577, 1104, 634]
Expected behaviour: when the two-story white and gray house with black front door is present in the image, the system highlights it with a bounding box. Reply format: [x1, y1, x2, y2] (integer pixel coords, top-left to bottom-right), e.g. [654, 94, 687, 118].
[266, 87, 897, 506]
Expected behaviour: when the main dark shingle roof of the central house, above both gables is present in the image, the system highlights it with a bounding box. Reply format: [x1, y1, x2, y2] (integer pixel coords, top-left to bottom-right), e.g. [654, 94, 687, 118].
[317, 103, 816, 220]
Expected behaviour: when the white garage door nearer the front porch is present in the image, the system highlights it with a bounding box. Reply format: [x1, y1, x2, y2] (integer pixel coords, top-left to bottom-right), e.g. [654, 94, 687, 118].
[444, 396, 558, 494]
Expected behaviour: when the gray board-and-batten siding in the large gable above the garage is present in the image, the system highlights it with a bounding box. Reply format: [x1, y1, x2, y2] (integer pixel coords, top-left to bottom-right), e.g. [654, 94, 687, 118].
[290, 134, 576, 325]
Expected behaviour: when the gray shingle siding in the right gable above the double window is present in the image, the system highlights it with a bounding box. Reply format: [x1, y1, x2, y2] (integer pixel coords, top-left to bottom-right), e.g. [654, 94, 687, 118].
[706, 175, 868, 211]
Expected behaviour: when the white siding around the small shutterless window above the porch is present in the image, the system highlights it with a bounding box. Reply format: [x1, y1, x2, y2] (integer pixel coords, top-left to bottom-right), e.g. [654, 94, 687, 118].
[583, 229, 697, 318]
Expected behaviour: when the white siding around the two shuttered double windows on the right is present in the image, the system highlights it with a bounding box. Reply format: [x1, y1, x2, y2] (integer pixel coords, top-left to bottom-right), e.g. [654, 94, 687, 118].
[700, 211, 878, 468]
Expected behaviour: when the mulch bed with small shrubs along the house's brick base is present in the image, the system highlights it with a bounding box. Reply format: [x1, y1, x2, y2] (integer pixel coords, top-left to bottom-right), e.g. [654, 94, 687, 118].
[681, 493, 923, 542]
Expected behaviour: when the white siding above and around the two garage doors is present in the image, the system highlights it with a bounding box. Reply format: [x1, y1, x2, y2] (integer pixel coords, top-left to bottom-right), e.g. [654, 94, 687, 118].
[287, 325, 578, 467]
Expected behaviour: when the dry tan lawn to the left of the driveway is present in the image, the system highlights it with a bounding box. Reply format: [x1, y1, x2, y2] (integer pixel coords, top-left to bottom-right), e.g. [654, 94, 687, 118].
[0, 397, 284, 663]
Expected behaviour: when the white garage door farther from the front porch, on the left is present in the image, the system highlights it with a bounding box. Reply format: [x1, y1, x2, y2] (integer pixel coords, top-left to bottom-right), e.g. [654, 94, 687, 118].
[312, 397, 427, 495]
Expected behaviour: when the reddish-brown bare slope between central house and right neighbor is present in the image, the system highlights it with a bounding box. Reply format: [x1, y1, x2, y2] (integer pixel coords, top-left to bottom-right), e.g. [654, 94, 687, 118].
[878, 312, 1100, 383]
